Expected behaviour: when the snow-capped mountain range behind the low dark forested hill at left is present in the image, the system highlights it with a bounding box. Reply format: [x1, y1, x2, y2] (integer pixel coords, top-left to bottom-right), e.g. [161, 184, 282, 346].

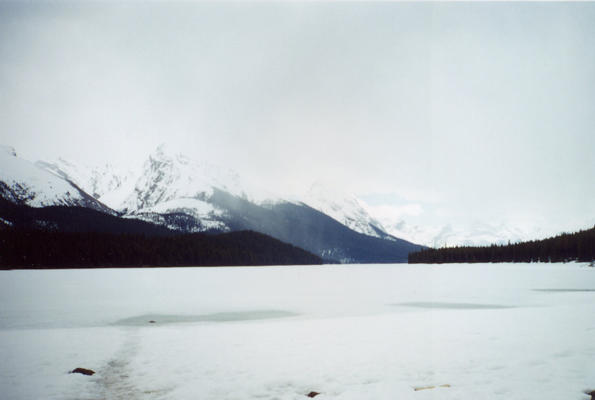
[0, 146, 421, 263]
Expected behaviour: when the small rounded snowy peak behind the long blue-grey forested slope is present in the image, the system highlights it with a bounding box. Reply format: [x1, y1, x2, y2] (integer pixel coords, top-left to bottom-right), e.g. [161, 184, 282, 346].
[302, 182, 390, 239]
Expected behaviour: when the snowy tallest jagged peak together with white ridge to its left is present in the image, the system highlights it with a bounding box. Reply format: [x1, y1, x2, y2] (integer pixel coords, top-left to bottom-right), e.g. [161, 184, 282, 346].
[37, 145, 280, 219]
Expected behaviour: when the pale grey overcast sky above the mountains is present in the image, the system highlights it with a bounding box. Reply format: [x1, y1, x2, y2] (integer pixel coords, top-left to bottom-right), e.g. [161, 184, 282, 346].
[0, 2, 595, 238]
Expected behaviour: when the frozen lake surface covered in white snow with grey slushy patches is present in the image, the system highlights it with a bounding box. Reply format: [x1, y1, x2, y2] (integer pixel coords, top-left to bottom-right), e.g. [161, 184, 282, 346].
[0, 263, 595, 400]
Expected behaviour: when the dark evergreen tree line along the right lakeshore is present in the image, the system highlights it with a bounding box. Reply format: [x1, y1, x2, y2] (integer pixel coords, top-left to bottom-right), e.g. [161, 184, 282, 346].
[408, 226, 595, 264]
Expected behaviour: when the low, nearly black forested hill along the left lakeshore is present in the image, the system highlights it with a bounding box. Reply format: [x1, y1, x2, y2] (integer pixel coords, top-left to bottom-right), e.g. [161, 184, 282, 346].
[0, 229, 322, 269]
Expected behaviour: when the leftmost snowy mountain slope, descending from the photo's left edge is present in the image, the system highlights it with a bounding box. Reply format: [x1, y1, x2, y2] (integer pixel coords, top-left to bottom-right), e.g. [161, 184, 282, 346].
[0, 146, 111, 212]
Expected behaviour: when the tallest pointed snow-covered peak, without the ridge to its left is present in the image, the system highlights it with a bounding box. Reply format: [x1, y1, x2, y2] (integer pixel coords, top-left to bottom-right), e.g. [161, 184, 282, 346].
[114, 145, 292, 231]
